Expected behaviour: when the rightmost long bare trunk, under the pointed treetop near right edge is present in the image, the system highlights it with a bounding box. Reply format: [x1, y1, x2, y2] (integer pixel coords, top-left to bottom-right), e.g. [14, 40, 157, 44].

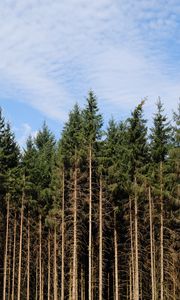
[160, 162, 164, 300]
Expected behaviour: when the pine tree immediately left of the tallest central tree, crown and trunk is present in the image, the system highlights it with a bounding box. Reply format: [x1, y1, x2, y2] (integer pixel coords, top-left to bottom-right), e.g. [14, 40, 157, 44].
[60, 104, 83, 300]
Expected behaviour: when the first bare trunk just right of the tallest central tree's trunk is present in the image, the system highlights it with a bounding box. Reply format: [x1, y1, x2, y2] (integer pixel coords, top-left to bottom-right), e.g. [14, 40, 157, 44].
[99, 178, 103, 300]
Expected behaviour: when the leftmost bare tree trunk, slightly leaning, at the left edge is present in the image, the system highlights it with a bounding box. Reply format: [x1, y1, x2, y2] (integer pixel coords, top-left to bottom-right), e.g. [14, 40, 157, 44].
[3, 195, 9, 300]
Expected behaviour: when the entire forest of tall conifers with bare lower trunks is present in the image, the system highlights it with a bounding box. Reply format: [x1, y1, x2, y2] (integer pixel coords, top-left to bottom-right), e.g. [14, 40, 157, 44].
[0, 91, 180, 300]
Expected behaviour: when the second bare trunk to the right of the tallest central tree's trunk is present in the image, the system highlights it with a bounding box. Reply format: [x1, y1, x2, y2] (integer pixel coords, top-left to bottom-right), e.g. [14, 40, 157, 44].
[114, 211, 119, 300]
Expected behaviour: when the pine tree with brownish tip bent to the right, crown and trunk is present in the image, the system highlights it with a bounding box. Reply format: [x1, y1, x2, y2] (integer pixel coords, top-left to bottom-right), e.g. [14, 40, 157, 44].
[127, 101, 148, 300]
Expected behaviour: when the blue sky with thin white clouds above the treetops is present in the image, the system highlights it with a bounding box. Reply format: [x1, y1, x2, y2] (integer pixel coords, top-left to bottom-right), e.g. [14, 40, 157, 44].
[0, 0, 180, 145]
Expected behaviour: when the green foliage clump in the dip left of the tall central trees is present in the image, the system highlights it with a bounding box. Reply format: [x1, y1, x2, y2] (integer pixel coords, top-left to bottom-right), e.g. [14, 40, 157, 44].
[23, 123, 55, 214]
